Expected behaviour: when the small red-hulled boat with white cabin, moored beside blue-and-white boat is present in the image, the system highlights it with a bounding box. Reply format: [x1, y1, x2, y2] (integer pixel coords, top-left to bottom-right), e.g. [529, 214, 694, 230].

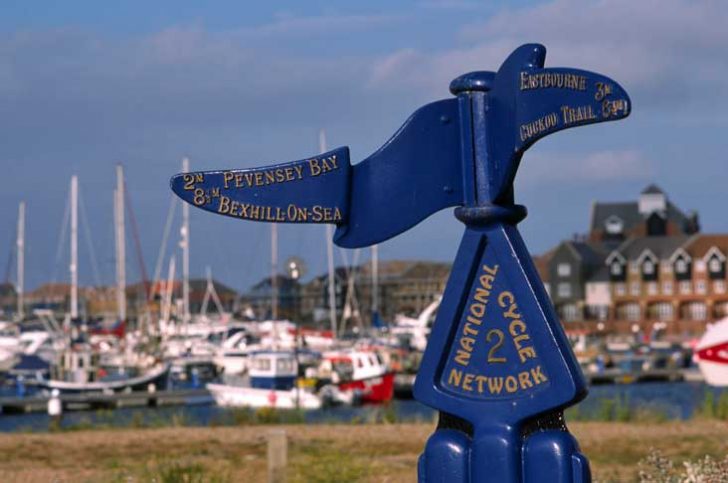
[319, 350, 394, 404]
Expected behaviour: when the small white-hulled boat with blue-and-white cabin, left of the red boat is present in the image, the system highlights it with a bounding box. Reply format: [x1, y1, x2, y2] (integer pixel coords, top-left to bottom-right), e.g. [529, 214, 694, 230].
[207, 350, 323, 410]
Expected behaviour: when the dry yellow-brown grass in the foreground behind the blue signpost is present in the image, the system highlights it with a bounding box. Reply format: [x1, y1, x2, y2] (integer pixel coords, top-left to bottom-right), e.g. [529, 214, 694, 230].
[0, 420, 728, 482]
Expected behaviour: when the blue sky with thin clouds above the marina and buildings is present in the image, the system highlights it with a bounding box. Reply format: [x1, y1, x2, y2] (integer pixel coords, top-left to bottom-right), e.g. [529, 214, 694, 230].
[0, 0, 728, 290]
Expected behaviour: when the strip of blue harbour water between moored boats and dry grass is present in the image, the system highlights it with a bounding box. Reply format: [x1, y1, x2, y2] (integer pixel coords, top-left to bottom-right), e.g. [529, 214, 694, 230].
[0, 382, 728, 432]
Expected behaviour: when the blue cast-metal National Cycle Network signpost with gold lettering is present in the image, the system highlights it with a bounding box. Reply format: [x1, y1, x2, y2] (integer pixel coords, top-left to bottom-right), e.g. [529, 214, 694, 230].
[171, 44, 631, 482]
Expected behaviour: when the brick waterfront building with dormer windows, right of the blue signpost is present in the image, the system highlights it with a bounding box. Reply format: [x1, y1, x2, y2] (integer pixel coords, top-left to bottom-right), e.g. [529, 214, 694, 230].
[536, 185, 728, 336]
